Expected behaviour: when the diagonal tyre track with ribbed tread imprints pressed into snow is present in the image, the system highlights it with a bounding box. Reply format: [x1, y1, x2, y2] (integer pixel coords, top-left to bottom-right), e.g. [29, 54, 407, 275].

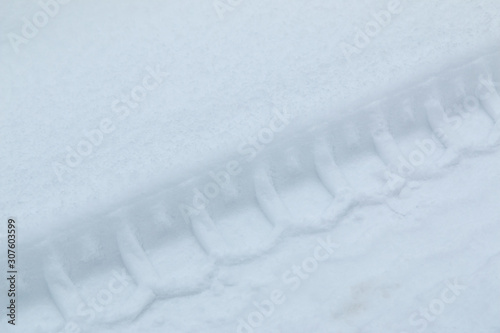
[14, 49, 500, 332]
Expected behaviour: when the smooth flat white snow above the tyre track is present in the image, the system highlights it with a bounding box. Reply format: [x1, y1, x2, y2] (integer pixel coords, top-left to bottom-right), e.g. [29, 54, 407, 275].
[0, 0, 500, 225]
